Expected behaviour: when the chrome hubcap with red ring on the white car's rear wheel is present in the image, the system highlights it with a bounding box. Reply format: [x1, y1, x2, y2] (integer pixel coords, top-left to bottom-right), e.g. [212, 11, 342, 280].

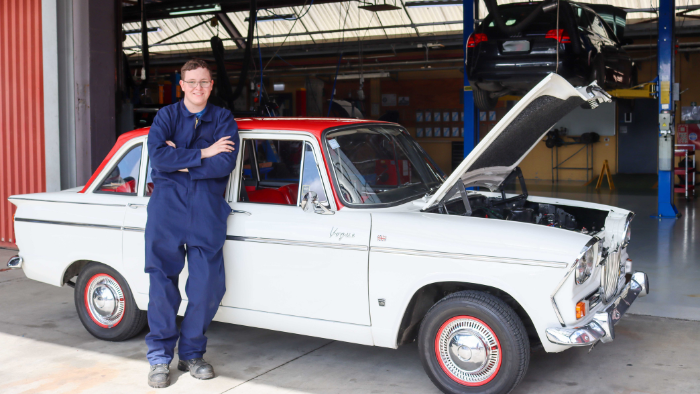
[85, 275, 124, 328]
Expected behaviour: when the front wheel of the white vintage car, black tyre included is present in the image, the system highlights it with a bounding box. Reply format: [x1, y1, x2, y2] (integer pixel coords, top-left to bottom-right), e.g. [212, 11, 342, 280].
[418, 290, 530, 394]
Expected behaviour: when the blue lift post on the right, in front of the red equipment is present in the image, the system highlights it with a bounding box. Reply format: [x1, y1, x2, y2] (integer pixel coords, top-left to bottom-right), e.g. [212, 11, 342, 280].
[657, 0, 679, 219]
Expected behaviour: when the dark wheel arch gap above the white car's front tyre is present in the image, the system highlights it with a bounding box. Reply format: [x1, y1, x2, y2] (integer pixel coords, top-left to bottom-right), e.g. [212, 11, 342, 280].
[396, 282, 542, 348]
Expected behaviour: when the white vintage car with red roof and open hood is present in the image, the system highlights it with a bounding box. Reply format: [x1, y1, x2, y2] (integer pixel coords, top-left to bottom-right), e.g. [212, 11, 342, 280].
[9, 75, 649, 393]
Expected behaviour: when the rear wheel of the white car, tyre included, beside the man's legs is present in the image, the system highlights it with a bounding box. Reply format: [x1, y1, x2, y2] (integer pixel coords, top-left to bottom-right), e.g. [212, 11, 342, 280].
[74, 263, 147, 342]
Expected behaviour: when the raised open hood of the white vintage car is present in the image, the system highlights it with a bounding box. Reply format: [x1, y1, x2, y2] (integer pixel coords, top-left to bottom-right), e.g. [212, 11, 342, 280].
[423, 74, 611, 209]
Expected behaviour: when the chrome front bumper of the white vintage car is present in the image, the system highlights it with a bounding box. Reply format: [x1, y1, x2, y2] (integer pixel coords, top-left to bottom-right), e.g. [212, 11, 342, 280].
[546, 272, 649, 346]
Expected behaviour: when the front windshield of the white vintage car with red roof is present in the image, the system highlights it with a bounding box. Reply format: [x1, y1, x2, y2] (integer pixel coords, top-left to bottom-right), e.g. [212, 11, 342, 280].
[326, 125, 444, 206]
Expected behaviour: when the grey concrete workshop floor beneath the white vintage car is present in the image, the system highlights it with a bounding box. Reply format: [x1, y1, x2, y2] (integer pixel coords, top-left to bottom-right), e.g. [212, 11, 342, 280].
[0, 188, 700, 394]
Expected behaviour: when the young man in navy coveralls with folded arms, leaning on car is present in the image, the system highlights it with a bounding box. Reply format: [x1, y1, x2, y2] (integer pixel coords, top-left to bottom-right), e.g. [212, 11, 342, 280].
[146, 59, 238, 388]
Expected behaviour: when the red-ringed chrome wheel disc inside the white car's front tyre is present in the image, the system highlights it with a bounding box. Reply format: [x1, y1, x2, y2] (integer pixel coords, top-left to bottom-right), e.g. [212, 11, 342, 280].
[435, 316, 503, 386]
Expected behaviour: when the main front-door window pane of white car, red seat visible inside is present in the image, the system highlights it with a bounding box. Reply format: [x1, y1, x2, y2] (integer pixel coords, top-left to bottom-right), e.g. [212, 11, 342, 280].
[238, 139, 304, 205]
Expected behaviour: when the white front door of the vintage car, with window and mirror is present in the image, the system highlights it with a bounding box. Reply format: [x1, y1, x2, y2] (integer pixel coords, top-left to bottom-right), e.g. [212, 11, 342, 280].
[222, 133, 371, 325]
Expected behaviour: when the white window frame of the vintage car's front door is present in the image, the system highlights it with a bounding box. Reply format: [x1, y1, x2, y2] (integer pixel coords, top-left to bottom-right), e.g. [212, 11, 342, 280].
[226, 129, 337, 210]
